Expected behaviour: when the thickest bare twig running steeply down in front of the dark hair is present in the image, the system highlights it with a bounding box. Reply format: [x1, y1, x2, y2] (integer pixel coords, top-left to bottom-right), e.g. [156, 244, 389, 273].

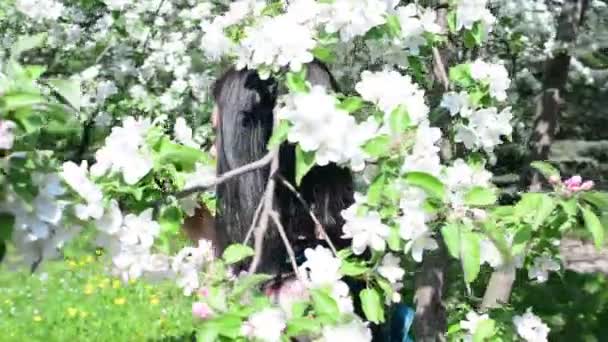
[249, 148, 279, 274]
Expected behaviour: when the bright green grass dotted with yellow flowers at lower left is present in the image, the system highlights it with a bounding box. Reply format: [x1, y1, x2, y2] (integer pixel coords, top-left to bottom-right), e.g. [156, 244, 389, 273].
[0, 243, 196, 342]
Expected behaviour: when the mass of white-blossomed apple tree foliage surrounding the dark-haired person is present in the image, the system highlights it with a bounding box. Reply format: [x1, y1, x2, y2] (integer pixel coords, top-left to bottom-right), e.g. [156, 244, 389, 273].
[0, 0, 608, 341]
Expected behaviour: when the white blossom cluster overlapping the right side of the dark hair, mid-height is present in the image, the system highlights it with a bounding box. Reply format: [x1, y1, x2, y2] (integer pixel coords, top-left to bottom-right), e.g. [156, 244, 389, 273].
[276, 86, 378, 171]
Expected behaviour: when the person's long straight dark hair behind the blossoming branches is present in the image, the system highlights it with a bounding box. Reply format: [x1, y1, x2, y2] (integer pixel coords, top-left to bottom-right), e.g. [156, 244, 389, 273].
[213, 61, 354, 273]
